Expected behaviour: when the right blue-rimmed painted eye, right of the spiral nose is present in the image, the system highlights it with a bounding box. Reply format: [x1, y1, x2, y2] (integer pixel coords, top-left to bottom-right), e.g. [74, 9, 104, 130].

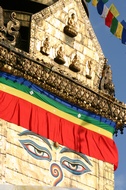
[60, 156, 90, 175]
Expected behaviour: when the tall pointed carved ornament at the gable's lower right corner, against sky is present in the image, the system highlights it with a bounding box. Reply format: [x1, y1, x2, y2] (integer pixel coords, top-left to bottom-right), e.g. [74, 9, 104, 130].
[99, 58, 115, 96]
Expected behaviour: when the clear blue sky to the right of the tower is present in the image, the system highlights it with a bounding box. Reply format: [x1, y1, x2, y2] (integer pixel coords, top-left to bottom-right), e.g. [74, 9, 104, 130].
[88, 0, 126, 190]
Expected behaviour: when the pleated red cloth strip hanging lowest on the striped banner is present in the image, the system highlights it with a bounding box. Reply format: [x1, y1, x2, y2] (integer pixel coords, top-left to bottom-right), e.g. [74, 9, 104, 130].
[0, 91, 118, 169]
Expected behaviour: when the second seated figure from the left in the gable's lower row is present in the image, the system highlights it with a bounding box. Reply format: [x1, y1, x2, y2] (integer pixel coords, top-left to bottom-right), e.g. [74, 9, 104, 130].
[54, 46, 65, 65]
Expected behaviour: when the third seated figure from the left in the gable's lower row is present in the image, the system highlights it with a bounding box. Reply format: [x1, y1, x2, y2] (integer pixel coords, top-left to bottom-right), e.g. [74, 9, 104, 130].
[69, 54, 80, 72]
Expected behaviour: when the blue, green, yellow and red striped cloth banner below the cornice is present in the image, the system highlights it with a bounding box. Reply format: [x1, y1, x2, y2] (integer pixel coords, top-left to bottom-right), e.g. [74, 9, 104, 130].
[0, 72, 118, 169]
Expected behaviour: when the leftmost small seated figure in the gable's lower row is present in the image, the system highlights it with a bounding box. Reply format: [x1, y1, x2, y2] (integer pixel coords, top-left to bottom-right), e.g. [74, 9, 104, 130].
[40, 37, 50, 55]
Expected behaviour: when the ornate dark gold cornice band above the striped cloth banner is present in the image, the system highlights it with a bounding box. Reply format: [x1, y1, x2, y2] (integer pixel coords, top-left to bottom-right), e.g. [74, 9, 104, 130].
[0, 42, 126, 133]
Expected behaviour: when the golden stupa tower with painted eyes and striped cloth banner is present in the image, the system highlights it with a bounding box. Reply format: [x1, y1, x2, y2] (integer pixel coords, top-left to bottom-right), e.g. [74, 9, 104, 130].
[0, 0, 126, 190]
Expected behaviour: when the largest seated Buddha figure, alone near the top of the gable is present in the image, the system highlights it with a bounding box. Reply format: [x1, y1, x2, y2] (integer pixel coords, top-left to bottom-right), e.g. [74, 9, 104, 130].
[64, 13, 78, 37]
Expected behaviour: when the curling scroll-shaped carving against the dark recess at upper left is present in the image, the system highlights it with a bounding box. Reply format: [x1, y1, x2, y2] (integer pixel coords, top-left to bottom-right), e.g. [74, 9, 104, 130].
[0, 7, 20, 46]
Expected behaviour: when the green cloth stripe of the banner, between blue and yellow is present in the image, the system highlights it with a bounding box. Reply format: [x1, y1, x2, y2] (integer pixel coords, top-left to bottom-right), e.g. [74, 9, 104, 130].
[0, 77, 114, 134]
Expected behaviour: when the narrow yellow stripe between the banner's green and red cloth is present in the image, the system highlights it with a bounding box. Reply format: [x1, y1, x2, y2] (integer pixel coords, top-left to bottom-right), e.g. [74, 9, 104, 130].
[0, 83, 112, 139]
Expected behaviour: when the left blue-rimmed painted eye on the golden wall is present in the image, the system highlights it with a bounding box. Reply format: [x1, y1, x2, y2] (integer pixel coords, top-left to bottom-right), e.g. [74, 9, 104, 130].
[19, 140, 52, 161]
